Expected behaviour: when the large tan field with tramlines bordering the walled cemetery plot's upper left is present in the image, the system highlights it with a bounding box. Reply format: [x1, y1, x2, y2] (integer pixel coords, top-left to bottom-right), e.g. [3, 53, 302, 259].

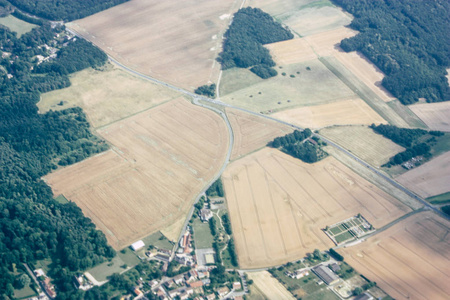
[222, 148, 410, 268]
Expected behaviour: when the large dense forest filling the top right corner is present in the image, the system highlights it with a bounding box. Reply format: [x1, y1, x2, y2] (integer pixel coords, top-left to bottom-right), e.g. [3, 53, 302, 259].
[333, 0, 450, 104]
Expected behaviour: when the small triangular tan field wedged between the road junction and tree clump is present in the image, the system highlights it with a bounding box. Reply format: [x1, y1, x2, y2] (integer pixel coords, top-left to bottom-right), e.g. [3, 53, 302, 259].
[227, 109, 293, 160]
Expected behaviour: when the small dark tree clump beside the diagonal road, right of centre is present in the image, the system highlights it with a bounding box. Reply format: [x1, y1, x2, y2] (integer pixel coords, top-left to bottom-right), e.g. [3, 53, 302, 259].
[270, 128, 326, 163]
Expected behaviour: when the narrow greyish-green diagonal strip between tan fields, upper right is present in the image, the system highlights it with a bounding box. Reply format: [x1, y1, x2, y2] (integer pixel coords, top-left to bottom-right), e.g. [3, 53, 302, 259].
[320, 57, 408, 127]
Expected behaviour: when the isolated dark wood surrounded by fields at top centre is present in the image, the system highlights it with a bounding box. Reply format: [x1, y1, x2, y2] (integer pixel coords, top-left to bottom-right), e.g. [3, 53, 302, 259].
[218, 7, 294, 78]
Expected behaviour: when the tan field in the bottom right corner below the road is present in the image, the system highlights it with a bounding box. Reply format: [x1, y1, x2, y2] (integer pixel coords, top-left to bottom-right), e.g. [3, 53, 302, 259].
[339, 212, 450, 300]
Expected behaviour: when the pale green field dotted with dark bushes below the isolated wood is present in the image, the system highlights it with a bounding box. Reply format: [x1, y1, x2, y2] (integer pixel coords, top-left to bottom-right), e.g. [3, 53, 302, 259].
[221, 60, 355, 113]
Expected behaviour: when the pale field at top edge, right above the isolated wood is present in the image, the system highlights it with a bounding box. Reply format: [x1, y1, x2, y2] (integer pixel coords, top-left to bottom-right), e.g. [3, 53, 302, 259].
[246, 0, 352, 36]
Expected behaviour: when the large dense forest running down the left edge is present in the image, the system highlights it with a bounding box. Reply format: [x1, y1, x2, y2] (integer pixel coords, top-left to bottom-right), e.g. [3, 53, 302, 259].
[0, 24, 115, 299]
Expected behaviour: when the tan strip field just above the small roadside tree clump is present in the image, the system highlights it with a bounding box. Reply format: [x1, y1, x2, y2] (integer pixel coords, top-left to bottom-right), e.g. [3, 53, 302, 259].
[273, 98, 387, 128]
